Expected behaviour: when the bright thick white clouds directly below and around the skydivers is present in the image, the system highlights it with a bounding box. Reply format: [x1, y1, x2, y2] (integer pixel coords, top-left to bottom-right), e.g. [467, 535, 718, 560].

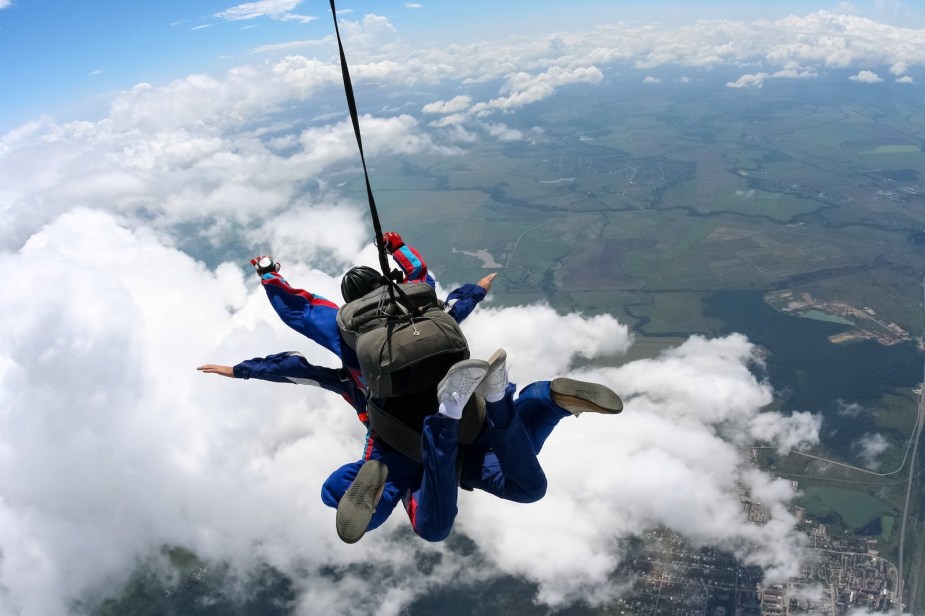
[0, 209, 818, 614]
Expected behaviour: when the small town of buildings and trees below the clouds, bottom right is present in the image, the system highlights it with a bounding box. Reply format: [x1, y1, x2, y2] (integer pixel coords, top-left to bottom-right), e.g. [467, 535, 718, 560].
[614, 512, 897, 616]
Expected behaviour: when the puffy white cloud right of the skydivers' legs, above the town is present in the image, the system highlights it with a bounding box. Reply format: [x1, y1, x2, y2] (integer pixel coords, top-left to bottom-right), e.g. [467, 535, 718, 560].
[460, 332, 817, 605]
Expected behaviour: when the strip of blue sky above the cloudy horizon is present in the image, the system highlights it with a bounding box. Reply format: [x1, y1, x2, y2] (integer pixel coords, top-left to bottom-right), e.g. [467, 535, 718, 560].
[0, 0, 923, 131]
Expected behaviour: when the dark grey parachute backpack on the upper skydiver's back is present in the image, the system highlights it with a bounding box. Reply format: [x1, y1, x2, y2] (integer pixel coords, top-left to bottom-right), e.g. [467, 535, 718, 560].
[337, 283, 469, 398]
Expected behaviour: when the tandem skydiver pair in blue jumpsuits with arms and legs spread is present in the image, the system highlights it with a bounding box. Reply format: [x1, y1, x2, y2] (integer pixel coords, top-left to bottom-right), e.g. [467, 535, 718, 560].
[198, 232, 623, 543]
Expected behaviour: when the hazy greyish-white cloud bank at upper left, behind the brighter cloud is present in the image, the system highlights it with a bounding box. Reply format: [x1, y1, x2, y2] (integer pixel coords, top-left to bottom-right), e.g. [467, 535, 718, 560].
[0, 57, 455, 248]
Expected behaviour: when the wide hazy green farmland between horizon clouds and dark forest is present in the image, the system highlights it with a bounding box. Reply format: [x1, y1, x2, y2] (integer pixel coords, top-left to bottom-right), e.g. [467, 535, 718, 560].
[360, 81, 925, 333]
